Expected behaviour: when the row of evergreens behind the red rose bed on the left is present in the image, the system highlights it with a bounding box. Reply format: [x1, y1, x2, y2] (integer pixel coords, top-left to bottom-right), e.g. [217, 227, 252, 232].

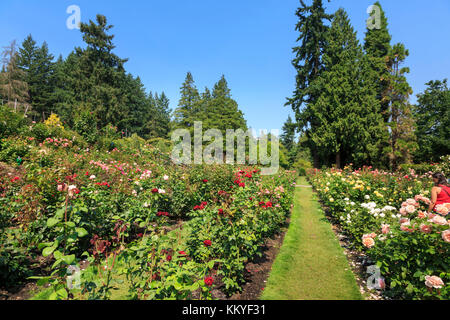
[0, 15, 247, 145]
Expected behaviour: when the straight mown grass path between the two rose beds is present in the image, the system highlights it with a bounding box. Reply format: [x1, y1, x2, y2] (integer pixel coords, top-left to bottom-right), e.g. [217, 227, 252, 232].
[261, 178, 362, 300]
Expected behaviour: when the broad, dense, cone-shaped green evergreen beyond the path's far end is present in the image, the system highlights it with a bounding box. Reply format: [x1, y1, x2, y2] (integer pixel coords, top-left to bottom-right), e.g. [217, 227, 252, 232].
[309, 9, 384, 168]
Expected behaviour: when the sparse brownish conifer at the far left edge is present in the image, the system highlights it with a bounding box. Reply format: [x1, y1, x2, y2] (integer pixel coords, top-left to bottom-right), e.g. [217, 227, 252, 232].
[0, 41, 29, 111]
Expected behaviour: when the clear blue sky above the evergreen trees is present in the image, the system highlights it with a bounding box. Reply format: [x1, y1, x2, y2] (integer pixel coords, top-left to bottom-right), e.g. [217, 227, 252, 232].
[0, 0, 450, 130]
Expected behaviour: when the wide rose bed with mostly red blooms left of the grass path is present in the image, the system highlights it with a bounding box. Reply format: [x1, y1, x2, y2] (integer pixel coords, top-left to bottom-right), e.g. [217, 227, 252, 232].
[0, 133, 295, 299]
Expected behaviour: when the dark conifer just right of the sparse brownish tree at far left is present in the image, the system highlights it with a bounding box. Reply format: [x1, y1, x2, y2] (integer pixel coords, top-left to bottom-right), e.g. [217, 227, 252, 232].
[17, 35, 54, 120]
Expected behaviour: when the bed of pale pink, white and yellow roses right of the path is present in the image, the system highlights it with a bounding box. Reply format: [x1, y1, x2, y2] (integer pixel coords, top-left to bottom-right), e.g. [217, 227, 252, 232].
[309, 168, 450, 299]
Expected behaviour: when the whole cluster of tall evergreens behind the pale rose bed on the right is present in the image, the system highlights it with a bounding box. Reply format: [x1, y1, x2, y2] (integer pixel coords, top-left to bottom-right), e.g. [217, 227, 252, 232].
[284, 0, 450, 170]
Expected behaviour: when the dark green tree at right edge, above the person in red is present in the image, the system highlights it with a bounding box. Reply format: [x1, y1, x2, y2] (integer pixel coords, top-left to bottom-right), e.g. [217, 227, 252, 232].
[413, 79, 450, 162]
